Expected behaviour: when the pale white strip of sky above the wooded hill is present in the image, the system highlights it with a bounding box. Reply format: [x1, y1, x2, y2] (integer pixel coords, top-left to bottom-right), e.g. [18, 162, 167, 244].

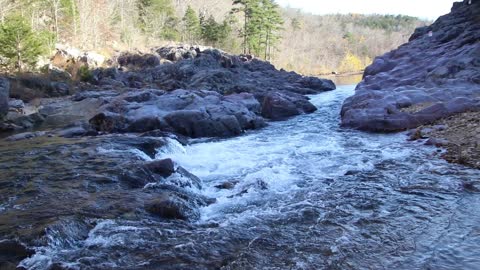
[276, 0, 455, 20]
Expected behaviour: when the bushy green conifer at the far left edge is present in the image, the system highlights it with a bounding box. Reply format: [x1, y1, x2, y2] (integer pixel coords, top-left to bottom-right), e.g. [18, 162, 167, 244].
[0, 16, 48, 71]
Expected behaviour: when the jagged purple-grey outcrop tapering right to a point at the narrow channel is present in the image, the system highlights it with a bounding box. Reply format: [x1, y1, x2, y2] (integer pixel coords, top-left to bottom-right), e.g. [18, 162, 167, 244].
[83, 47, 335, 138]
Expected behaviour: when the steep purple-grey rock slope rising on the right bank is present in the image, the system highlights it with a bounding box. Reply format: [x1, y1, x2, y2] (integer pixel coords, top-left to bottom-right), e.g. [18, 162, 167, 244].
[341, 0, 480, 132]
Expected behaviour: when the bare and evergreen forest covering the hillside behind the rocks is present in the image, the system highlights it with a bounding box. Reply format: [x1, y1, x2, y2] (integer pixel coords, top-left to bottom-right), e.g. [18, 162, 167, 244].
[0, 0, 430, 75]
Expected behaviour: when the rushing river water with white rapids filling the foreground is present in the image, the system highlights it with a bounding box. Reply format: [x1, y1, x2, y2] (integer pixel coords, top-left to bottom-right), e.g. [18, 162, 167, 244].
[0, 86, 480, 269]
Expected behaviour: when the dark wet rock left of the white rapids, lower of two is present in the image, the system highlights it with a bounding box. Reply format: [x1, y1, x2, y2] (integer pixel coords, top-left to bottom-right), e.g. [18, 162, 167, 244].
[145, 191, 200, 220]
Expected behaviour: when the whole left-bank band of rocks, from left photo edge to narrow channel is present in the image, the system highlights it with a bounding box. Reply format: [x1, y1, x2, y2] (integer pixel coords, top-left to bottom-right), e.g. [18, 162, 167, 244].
[1, 46, 335, 138]
